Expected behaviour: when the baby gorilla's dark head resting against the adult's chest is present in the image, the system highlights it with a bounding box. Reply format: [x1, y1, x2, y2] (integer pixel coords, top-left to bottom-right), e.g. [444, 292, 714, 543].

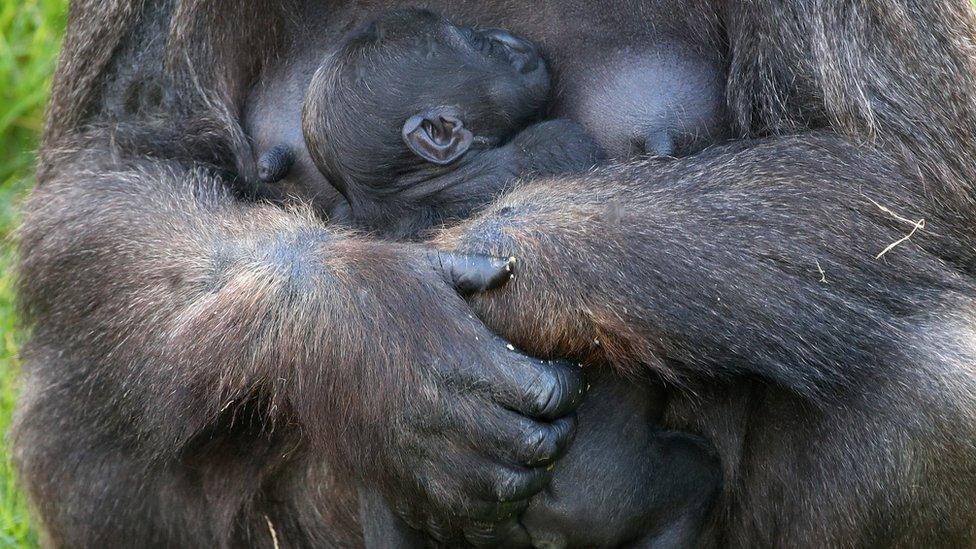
[302, 10, 549, 214]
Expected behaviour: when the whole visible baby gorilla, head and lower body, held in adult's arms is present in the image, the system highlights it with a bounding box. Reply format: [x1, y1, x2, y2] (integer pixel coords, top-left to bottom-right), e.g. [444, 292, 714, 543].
[260, 10, 721, 547]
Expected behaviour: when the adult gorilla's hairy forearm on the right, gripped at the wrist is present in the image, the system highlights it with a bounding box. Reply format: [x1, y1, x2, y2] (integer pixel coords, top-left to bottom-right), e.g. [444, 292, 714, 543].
[447, 134, 972, 393]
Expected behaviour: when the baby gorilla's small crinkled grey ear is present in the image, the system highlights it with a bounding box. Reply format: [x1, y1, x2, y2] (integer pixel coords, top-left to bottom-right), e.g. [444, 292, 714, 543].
[403, 107, 474, 166]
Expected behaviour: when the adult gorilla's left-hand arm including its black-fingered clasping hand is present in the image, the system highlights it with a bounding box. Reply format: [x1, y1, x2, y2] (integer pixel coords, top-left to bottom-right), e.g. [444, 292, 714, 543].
[18, 145, 581, 539]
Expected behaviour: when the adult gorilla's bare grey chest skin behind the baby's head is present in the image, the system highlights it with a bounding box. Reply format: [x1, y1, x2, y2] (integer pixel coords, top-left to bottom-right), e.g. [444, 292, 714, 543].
[245, 0, 724, 193]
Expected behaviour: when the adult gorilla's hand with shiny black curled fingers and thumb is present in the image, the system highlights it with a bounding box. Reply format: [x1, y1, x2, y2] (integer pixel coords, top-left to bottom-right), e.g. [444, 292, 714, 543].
[354, 247, 583, 545]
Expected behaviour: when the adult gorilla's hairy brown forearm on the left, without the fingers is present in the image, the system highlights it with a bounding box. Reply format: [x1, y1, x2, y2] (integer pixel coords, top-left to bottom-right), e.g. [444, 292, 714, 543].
[21, 151, 409, 458]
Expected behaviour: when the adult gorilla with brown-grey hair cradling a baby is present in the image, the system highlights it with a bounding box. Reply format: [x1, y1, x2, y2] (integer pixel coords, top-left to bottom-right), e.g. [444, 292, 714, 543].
[15, 0, 976, 546]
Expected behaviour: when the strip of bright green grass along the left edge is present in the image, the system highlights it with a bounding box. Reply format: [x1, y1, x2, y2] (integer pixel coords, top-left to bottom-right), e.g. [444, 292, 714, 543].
[0, 0, 67, 547]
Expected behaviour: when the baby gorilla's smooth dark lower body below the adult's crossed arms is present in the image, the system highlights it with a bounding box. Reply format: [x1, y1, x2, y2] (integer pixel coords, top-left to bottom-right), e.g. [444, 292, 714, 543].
[522, 369, 722, 547]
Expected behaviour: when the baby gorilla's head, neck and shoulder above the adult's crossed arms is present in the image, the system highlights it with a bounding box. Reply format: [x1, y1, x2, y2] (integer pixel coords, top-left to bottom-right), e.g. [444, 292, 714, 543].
[302, 6, 603, 238]
